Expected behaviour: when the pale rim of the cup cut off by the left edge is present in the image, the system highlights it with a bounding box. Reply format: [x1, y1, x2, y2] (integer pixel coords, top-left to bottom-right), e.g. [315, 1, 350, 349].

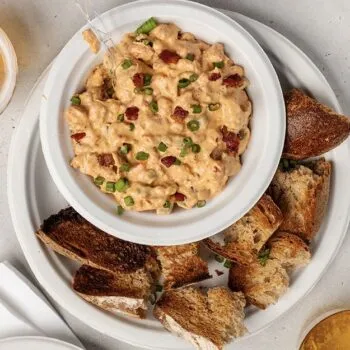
[0, 28, 18, 114]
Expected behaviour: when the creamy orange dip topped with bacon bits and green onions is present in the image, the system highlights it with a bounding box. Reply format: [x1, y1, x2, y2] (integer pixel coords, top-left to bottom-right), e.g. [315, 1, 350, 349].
[66, 24, 252, 214]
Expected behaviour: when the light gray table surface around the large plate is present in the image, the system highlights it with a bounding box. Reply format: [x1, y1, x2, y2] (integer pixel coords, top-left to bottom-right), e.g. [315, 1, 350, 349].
[0, 0, 350, 350]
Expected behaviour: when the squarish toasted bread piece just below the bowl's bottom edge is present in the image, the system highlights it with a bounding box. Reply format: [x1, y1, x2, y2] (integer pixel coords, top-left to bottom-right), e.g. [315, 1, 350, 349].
[155, 242, 211, 289]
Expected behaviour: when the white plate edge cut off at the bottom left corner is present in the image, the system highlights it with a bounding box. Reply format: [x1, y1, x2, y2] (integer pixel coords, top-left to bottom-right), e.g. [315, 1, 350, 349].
[0, 337, 82, 350]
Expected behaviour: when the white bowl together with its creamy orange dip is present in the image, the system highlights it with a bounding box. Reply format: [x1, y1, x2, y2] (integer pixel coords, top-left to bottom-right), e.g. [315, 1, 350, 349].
[40, 1, 285, 245]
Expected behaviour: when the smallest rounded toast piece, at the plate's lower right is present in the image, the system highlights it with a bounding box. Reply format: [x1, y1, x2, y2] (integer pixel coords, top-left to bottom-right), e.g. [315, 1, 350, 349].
[266, 231, 311, 270]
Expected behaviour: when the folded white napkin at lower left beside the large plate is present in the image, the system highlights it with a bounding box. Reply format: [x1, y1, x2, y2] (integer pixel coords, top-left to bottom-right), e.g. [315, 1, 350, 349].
[0, 262, 83, 348]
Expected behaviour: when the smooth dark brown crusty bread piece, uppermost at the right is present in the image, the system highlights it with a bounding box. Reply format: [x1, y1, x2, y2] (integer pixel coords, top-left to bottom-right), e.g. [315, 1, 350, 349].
[283, 89, 350, 160]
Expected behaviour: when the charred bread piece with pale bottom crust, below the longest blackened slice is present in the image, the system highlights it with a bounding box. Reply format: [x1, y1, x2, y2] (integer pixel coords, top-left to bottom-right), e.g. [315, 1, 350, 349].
[73, 265, 153, 318]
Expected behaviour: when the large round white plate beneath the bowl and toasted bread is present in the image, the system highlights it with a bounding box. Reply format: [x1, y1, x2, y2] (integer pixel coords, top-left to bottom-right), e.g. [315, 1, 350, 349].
[8, 13, 350, 350]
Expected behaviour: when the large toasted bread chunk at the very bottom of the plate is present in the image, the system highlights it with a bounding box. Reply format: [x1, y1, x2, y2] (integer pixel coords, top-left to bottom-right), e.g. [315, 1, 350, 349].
[153, 287, 246, 350]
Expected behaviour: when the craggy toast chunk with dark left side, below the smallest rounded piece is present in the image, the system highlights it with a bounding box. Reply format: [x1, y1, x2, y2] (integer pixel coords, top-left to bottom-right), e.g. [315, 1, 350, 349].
[228, 259, 289, 309]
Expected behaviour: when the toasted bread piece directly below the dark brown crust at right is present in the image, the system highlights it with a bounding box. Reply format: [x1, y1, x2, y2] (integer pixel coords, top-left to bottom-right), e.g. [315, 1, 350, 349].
[269, 158, 332, 242]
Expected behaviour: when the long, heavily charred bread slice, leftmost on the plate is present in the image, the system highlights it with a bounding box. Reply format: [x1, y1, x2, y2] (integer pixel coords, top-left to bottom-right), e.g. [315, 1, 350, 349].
[37, 208, 159, 278]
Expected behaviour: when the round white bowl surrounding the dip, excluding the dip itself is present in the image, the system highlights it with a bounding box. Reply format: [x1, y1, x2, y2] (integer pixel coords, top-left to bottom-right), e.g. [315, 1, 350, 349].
[40, 0, 285, 245]
